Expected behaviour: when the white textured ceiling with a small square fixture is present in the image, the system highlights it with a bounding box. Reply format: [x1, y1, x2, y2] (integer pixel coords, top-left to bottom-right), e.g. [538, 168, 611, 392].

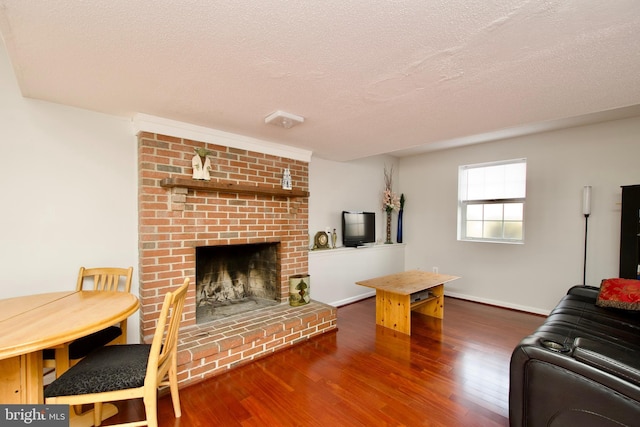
[0, 0, 640, 160]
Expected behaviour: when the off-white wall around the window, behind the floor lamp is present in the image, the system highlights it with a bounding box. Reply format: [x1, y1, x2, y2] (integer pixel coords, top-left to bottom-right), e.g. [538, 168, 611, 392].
[400, 118, 640, 313]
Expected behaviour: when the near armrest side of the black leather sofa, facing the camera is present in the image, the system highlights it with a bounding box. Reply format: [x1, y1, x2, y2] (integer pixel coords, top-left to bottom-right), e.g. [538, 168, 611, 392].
[509, 334, 640, 427]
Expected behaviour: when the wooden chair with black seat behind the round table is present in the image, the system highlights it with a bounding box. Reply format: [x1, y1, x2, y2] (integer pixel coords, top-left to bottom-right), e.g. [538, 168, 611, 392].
[42, 267, 133, 377]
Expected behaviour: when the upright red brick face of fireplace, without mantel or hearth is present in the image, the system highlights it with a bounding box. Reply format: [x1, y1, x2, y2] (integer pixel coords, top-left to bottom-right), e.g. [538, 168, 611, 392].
[138, 132, 309, 340]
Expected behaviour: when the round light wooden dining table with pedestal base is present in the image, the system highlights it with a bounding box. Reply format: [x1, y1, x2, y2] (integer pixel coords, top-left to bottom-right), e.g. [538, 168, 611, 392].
[0, 291, 140, 404]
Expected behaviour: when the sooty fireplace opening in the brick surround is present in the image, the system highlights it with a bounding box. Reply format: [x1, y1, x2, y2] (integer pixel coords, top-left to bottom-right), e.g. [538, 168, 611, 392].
[196, 243, 280, 323]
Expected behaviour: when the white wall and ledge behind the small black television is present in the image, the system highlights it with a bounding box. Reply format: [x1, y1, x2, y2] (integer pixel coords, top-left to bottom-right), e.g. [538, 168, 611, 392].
[309, 156, 405, 306]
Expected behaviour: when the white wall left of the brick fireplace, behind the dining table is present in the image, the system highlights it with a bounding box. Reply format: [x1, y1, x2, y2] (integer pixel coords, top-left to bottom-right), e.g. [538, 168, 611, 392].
[0, 43, 139, 341]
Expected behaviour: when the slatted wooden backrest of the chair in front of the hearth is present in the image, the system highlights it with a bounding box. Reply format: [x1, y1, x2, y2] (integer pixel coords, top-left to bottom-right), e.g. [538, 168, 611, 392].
[144, 278, 189, 390]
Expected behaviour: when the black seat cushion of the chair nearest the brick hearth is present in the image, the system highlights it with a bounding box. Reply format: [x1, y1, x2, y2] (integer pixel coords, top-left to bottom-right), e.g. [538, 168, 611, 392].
[44, 344, 151, 397]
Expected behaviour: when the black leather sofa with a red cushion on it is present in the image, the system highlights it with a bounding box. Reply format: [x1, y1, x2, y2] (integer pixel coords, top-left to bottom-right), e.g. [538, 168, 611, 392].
[509, 286, 640, 427]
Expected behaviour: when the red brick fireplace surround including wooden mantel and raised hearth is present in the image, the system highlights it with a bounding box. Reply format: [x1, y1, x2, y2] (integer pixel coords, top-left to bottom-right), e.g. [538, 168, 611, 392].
[138, 131, 336, 385]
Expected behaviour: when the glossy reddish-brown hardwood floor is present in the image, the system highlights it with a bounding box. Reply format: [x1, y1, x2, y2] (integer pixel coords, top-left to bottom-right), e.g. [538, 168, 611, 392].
[105, 298, 544, 427]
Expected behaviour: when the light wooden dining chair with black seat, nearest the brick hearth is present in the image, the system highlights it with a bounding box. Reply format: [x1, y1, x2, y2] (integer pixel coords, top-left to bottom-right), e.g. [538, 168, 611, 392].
[44, 278, 189, 427]
